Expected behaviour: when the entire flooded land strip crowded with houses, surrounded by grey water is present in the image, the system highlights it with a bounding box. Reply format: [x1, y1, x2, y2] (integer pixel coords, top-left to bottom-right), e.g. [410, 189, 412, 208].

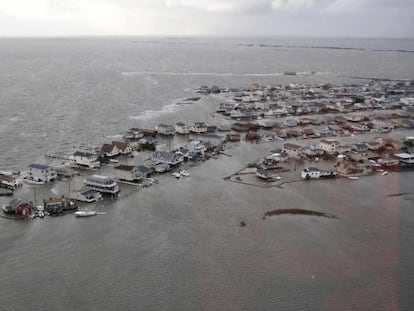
[0, 80, 414, 219]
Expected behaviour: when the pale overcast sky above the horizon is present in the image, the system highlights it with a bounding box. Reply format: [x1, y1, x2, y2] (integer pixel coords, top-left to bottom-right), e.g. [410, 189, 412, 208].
[0, 0, 414, 37]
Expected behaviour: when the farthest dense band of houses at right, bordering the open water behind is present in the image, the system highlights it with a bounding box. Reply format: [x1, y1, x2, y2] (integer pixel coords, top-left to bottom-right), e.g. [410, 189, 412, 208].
[216, 81, 414, 118]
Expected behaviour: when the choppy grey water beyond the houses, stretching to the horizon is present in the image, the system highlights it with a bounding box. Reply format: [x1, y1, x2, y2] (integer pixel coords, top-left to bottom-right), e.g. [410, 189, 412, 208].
[0, 38, 414, 168]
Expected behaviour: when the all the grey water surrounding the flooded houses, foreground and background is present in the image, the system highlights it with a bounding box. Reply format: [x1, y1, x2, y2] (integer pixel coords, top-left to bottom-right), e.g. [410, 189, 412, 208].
[0, 37, 414, 310]
